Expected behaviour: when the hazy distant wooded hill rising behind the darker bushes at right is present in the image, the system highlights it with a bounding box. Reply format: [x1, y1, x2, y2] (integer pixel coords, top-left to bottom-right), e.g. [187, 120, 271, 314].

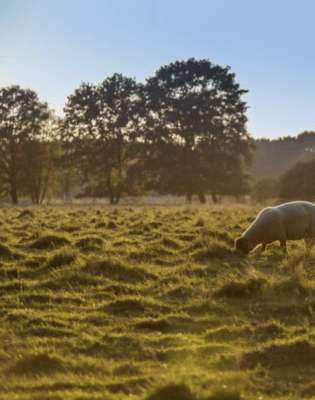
[251, 131, 315, 178]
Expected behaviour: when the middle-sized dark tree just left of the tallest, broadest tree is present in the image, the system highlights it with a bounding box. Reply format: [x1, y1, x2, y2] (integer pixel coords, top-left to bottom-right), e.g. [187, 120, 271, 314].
[63, 74, 142, 204]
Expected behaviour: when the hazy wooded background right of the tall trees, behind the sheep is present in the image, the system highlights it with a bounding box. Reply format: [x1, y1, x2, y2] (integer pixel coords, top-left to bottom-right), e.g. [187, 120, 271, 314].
[251, 130, 315, 202]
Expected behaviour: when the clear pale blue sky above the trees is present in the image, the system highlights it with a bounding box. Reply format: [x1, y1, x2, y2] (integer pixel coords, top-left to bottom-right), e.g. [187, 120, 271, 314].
[0, 0, 315, 138]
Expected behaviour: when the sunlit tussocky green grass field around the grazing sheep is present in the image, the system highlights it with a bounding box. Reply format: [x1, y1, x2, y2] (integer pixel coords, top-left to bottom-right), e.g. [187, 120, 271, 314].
[0, 205, 315, 400]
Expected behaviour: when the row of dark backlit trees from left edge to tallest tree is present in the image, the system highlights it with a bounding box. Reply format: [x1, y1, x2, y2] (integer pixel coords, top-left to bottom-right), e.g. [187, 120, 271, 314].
[0, 58, 254, 204]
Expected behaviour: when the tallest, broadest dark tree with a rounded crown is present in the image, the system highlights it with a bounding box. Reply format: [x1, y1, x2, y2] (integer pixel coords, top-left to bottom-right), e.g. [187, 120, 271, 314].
[141, 58, 253, 201]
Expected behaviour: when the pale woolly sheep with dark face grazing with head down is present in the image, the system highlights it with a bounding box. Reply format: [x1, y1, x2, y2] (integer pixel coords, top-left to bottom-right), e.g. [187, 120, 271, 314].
[235, 201, 315, 254]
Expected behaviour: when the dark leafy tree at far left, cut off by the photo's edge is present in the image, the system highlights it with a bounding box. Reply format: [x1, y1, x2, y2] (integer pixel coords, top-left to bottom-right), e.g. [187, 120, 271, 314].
[0, 85, 50, 204]
